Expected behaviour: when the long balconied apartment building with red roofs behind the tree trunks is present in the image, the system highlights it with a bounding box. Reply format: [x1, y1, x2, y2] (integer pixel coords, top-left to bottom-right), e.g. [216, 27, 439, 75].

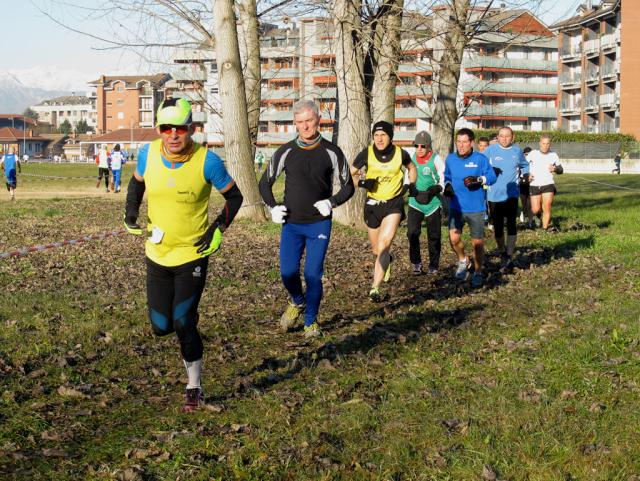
[172, 9, 557, 146]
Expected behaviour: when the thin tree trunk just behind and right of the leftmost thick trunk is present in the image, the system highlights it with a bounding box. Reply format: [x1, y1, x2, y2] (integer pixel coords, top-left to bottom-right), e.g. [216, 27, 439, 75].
[237, 0, 262, 155]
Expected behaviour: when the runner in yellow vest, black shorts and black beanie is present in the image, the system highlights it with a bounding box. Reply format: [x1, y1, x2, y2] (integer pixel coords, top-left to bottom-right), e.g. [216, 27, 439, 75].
[351, 120, 415, 302]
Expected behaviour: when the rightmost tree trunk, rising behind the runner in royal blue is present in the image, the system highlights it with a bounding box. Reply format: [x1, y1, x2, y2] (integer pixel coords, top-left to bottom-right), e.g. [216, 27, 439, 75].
[433, 0, 470, 159]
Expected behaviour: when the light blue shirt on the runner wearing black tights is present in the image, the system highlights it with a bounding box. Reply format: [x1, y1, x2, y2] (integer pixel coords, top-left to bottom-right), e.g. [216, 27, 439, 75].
[484, 144, 529, 202]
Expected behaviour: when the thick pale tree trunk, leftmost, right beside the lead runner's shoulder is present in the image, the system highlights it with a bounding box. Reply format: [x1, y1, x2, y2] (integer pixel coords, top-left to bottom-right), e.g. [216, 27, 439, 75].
[213, 0, 265, 220]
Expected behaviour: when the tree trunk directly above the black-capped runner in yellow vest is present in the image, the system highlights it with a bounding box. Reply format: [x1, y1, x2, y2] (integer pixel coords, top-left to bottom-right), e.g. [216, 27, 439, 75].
[371, 0, 404, 125]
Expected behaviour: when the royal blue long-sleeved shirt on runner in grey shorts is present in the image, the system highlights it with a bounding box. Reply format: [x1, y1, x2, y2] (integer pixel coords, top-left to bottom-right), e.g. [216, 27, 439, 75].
[444, 151, 496, 213]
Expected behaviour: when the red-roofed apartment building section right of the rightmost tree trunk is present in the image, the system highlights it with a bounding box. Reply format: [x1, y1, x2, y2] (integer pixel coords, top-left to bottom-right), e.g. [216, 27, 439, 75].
[458, 9, 558, 130]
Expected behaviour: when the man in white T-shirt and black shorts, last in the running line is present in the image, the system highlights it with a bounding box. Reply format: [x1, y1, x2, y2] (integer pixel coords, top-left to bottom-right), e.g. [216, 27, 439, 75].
[527, 135, 564, 232]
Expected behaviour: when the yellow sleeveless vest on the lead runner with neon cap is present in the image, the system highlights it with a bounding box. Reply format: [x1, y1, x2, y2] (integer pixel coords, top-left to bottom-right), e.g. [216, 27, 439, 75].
[144, 140, 211, 267]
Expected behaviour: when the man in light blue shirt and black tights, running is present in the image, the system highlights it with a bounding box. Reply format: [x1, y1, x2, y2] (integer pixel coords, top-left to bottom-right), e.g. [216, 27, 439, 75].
[484, 126, 529, 269]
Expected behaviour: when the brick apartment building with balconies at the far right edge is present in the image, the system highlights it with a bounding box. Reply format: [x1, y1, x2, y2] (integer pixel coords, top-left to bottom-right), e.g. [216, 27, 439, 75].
[552, 0, 640, 138]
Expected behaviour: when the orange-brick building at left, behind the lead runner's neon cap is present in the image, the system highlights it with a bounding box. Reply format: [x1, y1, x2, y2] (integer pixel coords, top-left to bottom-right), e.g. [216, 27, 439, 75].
[89, 73, 171, 134]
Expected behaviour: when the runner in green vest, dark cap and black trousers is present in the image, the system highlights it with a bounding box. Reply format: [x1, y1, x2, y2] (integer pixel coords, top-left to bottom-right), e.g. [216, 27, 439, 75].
[407, 130, 444, 275]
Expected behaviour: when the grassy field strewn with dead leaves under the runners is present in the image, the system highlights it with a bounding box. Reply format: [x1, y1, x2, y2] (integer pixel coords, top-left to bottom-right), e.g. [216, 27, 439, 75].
[0, 164, 640, 481]
